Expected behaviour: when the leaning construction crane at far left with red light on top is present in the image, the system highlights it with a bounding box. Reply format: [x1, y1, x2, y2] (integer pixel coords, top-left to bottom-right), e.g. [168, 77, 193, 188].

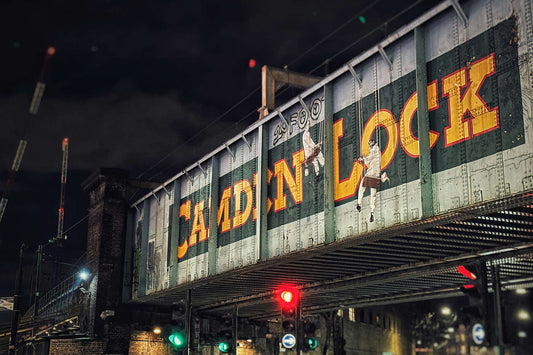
[0, 47, 56, 222]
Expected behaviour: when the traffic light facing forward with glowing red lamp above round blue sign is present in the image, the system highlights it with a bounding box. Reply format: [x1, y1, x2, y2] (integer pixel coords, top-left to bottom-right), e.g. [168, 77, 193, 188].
[278, 287, 300, 349]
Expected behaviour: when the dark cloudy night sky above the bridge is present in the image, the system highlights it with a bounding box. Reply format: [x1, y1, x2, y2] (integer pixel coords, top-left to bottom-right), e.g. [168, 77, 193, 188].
[0, 0, 438, 296]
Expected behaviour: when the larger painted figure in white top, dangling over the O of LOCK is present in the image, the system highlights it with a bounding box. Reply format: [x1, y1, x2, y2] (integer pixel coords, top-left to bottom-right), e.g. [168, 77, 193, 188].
[357, 139, 389, 222]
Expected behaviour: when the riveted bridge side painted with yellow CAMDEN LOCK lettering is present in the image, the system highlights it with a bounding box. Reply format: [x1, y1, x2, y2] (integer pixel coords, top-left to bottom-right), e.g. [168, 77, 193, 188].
[130, 1, 533, 297]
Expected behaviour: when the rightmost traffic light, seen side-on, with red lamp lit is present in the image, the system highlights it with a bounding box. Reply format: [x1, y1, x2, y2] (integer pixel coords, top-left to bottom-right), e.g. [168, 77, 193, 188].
[457, 261, 491, 345]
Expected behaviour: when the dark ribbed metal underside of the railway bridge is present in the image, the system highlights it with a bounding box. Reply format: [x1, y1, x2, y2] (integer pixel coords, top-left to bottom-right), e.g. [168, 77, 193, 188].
[130, 193, 533, 320]
